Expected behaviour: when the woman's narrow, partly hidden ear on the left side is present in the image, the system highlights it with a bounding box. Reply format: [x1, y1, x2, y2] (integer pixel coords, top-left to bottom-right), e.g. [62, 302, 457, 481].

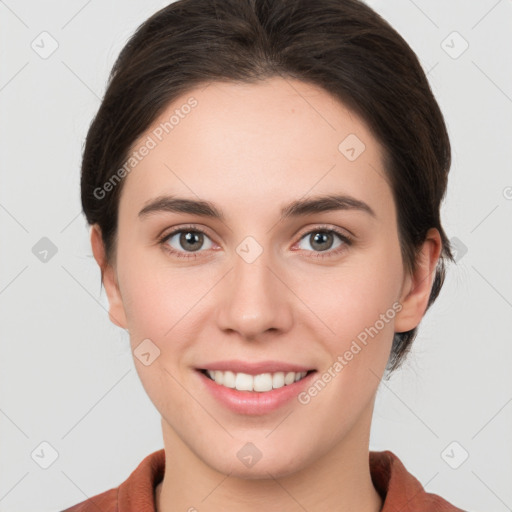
[91, 224, 127, 329]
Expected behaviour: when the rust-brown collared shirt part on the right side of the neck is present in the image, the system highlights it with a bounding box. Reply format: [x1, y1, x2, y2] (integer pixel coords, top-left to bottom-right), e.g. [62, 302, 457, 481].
[370, 450, 464, 512]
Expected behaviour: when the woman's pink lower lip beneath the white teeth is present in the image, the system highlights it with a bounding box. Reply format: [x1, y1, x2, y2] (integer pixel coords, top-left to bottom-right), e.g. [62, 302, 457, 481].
[196, 370, 316, 415]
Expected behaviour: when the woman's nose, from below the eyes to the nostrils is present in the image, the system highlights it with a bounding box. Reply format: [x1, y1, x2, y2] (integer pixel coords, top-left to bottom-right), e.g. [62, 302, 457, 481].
[217, 246, 294, 340]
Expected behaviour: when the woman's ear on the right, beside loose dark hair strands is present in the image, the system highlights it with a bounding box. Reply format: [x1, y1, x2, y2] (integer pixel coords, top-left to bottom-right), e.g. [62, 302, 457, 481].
[395, 228, 442, 332]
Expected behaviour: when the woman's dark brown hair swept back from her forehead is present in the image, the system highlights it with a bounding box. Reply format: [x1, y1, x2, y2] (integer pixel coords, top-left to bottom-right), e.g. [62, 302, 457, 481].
[81, 0, 454, 374]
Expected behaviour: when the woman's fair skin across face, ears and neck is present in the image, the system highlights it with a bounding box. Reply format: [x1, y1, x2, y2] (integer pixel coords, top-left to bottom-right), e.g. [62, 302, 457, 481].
[91, 78, 441, 512]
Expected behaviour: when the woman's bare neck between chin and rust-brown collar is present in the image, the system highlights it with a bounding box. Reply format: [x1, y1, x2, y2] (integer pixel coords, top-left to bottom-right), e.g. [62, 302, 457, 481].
[155, 407, 383, 512]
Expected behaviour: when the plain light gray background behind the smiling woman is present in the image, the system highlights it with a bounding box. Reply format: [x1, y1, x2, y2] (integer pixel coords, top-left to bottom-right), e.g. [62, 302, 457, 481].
[0, 0, 512, 512]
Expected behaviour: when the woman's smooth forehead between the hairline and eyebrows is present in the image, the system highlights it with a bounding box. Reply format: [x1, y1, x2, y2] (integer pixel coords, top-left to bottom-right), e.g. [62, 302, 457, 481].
[121, 78, 393, 221]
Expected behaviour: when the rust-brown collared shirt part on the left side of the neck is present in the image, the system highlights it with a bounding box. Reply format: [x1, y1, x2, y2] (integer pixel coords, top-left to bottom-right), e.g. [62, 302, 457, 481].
[62, 448, 165, 512]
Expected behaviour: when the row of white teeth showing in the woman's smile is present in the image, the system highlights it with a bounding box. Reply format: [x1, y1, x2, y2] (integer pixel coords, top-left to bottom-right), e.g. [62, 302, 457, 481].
[206, 370, 307, 393]
